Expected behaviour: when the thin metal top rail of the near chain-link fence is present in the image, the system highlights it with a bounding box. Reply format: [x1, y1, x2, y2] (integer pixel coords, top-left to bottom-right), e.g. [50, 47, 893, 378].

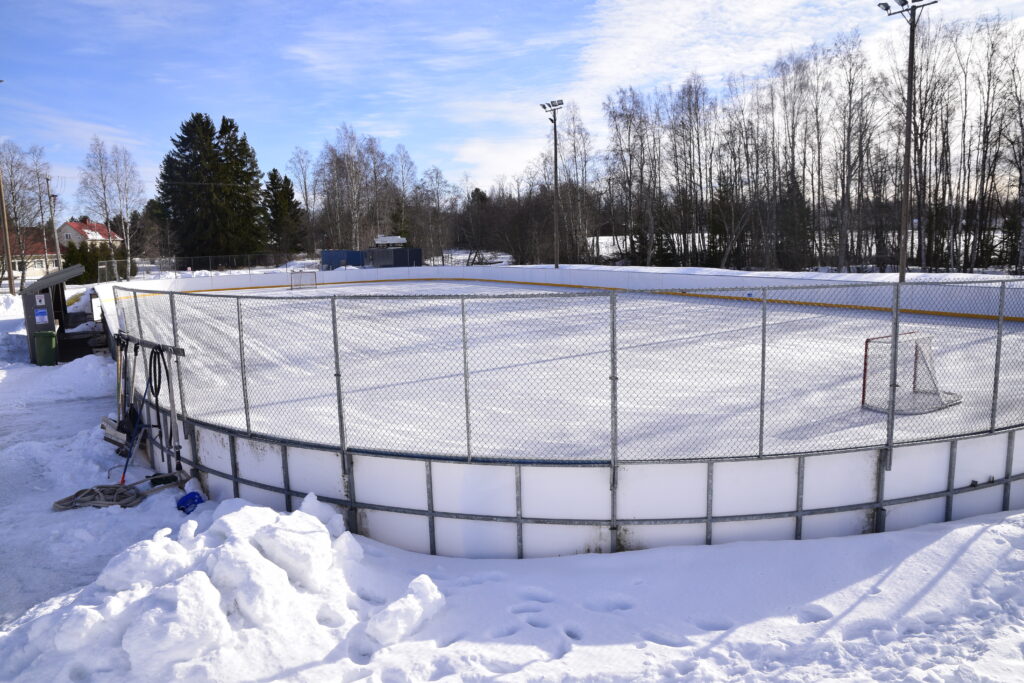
[113, 278, 1024, 300]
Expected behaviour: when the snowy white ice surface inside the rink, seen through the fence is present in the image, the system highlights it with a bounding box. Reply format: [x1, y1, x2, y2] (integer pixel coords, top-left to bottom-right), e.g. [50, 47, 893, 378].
[127, 274, 1024, 461]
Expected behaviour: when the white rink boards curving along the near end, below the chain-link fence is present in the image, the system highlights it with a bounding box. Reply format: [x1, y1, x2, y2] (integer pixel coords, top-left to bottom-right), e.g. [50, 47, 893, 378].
[172, 427, 1024, 558]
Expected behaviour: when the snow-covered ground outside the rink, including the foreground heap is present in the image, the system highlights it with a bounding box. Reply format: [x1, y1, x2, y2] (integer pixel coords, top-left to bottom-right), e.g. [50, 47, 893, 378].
[6, 290, 1024, 682]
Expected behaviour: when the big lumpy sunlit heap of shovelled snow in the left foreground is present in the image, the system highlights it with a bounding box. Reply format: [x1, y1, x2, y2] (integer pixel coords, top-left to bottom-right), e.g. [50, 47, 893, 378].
[0, 496, 444, 680]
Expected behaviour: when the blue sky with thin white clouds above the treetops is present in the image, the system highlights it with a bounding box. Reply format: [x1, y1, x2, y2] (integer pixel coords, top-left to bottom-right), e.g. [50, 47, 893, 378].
[0, 0, 1024, 213]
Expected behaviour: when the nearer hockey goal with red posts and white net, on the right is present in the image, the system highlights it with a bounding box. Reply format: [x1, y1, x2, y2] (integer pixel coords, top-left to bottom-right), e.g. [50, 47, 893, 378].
[860, 332, 963, 415]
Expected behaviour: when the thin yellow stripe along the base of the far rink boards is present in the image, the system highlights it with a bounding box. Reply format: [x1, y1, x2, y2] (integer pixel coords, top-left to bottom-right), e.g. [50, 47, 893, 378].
[97, 278, 1024, 323]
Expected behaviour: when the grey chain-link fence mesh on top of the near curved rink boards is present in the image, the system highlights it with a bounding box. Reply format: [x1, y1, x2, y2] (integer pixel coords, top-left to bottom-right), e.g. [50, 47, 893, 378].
[115, 281, 1024, 463]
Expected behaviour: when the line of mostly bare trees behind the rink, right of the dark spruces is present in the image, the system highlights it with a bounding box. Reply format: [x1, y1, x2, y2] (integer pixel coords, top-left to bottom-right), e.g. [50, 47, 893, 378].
[268, 16, 1024, 271]
